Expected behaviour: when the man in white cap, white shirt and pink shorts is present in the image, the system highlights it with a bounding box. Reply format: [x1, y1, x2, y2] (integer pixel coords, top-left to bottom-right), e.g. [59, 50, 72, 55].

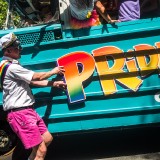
[0, 33, 66, 160]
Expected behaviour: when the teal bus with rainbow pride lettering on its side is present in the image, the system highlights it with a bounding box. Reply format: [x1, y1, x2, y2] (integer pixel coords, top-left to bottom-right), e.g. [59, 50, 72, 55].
[0, 0, 160, 155]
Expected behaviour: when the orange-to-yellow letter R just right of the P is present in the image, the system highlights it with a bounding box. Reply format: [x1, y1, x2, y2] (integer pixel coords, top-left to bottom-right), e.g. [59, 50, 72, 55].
[93, 46, 142, 95]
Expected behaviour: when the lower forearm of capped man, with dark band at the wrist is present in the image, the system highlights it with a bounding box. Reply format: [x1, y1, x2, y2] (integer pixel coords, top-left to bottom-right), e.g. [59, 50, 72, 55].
[30, 80, 67, 89]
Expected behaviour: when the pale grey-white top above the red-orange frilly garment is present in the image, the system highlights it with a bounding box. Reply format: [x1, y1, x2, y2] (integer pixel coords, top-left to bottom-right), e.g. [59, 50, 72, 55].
[69, 0, 97, 20]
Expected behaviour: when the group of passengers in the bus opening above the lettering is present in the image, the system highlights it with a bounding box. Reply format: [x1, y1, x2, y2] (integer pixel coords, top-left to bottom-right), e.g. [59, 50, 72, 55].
[69, 0, 158, 29]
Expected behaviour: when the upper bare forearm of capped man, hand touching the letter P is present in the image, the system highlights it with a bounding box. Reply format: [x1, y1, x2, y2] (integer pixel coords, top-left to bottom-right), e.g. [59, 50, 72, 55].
[32, 66, 65, 81]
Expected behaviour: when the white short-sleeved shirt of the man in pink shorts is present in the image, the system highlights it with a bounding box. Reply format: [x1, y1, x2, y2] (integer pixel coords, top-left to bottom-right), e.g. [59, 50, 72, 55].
[1, 57, 35, 111]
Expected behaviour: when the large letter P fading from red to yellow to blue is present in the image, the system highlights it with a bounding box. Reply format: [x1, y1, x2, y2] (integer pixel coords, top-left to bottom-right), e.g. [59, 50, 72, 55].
[57, 51, 95, 103]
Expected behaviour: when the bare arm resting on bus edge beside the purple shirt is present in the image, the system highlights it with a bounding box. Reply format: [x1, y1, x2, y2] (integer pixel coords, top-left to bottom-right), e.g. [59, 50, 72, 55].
[95, 1, 119, 23]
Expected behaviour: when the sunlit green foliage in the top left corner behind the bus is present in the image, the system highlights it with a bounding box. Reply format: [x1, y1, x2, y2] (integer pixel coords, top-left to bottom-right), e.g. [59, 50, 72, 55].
[0, 0, 20, 29]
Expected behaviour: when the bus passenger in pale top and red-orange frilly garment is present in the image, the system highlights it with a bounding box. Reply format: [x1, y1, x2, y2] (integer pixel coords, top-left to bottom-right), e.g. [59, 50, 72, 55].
[69, 0, 100, 29]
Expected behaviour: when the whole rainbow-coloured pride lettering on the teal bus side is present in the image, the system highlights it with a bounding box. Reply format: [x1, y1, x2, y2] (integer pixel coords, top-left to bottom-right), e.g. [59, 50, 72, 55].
[57, 42, 160, 103]
